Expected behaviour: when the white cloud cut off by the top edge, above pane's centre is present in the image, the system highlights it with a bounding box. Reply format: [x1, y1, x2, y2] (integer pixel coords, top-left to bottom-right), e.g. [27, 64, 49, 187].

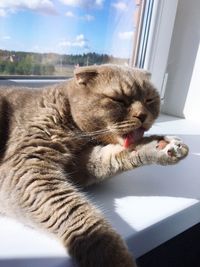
[60, 0, 104, 8]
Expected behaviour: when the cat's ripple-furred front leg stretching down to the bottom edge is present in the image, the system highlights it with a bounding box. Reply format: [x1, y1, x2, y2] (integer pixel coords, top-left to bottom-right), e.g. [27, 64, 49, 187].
[1, 162, 136, 267]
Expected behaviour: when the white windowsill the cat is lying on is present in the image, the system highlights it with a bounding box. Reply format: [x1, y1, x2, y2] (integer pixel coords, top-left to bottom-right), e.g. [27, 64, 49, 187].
[0, 115, 200, 267]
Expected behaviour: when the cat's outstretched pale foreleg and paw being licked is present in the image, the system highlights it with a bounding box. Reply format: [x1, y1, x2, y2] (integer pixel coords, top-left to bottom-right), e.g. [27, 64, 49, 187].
[78, 136, 188, 185]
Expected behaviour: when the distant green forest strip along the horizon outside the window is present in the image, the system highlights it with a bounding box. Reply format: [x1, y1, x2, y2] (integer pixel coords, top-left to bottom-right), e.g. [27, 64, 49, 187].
[0, 50, 128, 77]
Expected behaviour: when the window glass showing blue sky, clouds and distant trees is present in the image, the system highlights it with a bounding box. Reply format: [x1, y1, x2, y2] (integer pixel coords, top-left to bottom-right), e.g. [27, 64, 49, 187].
[0, 0, 138, 77]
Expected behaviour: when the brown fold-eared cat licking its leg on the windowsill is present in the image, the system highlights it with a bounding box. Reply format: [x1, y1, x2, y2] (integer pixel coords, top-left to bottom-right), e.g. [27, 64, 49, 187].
[0, 65, 188, 267]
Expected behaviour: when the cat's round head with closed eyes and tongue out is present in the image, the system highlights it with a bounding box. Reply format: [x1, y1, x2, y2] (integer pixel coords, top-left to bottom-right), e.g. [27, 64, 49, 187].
[69, 65, 160, 149]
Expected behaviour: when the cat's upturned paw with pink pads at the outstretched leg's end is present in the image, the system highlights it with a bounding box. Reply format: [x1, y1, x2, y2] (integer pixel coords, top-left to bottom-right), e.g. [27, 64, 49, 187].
[157, 136, 189, 163]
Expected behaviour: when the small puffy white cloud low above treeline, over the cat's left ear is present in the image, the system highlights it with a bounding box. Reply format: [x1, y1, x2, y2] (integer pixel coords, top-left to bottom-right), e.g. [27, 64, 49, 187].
[58, 34, 88, 48]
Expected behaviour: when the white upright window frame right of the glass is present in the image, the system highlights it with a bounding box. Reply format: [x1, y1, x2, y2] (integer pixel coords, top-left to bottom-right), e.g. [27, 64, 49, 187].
[135, 0, 178, 99]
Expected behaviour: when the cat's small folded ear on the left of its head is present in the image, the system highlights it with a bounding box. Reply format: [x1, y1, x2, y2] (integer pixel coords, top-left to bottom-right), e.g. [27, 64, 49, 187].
[74, 66, 98, 85]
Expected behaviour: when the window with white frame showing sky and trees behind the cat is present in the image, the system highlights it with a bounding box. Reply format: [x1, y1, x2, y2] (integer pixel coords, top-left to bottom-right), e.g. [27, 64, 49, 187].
[0, 0, 178, 98]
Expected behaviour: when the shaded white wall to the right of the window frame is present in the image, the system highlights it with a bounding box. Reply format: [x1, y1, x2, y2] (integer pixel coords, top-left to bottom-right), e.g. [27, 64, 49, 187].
[162, 0, 200, 117]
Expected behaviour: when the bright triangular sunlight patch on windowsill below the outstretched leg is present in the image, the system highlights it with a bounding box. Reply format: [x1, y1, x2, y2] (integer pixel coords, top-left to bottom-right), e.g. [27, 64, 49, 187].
[115, 196, 199, 232]
